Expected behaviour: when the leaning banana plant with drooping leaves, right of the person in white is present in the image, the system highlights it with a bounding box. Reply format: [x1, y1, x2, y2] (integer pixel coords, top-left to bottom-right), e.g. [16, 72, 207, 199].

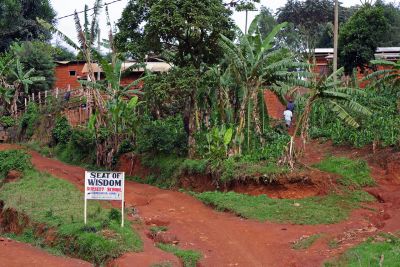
[273, 68, 371, 167]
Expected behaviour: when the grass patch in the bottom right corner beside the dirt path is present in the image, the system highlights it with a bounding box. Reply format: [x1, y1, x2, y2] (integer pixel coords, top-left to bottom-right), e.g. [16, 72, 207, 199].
[325, 234, 400, 267]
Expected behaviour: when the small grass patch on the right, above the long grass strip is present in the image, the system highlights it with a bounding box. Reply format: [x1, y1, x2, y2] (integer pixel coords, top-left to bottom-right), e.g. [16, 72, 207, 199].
[314, 157, 375, 187]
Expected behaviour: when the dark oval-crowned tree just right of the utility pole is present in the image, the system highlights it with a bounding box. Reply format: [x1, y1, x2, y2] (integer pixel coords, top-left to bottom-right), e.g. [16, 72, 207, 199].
[339, 4, 389, 74]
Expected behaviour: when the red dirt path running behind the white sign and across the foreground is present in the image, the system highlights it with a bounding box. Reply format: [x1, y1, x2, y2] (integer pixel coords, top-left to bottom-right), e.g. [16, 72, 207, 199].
[0, 143, 400, 267]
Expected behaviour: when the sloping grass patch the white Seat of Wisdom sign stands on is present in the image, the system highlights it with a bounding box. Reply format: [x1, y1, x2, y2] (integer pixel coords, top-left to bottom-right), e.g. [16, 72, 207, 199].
[0, 170, 143, 264]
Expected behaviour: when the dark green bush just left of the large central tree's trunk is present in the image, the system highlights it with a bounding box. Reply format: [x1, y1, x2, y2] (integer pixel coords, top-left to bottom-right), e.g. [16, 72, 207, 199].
[136, 116, 187, 155]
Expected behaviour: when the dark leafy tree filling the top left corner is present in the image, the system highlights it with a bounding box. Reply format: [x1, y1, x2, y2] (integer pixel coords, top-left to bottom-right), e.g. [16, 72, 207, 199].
[0, 0, 56, 52]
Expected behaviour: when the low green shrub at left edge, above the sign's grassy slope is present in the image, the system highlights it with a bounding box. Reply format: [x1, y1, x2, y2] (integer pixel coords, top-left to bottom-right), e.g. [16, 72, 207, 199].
[0, 150, 32, 179]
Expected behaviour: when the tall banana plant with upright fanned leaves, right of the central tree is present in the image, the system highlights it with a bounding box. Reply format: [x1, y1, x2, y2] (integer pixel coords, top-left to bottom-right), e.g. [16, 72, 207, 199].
[220, 17, 302, 153]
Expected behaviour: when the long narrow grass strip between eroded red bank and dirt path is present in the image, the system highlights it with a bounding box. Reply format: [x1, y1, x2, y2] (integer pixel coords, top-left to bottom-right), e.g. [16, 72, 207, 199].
[194, 191, 374, 225]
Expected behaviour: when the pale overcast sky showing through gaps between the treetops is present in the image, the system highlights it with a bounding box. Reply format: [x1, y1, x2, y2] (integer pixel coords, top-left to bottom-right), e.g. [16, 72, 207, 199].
[51, 0, 382, 48]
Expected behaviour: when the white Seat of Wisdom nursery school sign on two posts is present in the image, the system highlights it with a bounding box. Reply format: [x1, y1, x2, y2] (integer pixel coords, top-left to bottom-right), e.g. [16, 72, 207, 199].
[84, 171, 125, 227]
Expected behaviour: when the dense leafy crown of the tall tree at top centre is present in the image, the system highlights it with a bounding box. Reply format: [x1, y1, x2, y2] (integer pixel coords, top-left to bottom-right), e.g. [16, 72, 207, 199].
[115, 0, 234, 68]
